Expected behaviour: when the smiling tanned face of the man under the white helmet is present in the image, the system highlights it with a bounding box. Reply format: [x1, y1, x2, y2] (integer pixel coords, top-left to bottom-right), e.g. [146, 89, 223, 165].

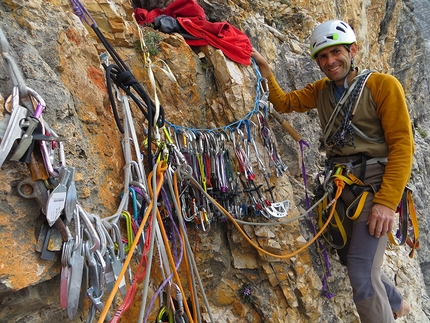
[316, 44, 356, 85]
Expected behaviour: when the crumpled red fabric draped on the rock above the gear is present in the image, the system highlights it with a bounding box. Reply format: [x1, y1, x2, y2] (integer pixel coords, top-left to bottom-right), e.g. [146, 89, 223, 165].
[134, 0, 252, 65]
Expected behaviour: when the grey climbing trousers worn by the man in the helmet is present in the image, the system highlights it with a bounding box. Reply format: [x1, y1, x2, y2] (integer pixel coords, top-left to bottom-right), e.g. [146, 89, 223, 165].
[332, 157, 402, 323]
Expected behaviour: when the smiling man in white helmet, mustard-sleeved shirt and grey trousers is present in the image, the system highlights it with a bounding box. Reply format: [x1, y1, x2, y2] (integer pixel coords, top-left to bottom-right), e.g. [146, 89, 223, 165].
[251, 20, 414, 323]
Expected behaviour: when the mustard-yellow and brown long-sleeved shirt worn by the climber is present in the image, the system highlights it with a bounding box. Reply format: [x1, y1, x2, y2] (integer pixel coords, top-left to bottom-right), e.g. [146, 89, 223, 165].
[267, 72, 414, 210]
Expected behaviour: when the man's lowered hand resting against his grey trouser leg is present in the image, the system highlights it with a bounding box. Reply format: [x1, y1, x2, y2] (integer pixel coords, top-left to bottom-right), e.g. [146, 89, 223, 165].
[367, 204, 396, 238]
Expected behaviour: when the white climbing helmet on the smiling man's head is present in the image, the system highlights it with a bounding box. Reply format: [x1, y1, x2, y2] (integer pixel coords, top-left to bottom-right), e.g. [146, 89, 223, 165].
[310, 20, 357, 59]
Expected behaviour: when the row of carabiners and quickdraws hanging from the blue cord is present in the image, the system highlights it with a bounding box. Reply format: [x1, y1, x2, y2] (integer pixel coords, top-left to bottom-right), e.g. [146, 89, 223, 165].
[165, 107, 287, 227]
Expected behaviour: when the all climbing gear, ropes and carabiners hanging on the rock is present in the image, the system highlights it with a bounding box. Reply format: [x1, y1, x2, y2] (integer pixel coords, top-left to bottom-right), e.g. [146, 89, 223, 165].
[0, 0, 420, 323]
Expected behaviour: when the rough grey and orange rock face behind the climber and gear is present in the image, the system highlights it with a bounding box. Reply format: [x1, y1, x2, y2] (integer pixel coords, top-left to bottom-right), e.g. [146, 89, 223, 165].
[0, 0, 430, 323]
